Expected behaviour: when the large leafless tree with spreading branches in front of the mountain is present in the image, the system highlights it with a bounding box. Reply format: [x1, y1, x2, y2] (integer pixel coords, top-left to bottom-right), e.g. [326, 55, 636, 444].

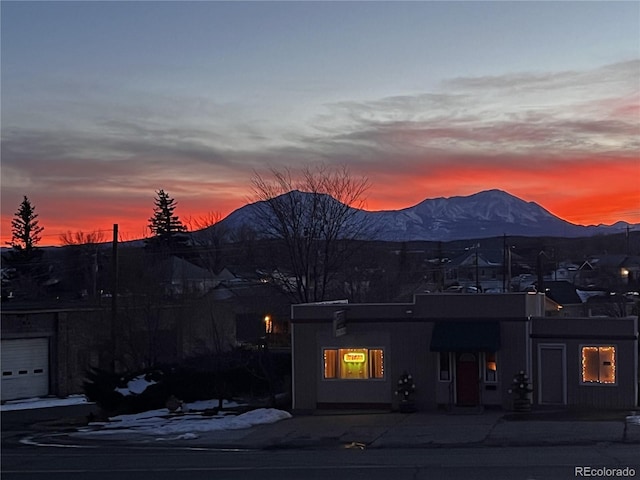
[252, 164, 371, 302]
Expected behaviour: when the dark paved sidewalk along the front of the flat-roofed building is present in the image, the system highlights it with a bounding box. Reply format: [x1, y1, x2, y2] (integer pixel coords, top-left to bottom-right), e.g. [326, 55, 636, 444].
[47, 411, 640, 449]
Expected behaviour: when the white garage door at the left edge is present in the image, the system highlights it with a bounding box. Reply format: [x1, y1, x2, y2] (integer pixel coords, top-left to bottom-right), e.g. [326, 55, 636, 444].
[0, 338, 49, 400]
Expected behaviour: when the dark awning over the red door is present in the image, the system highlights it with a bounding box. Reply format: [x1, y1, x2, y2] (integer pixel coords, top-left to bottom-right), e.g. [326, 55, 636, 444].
[431, 321, 500, 352]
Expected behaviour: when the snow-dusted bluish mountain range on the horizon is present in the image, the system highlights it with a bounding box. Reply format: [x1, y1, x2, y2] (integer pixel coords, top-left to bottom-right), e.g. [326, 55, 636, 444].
[214, 190, 640, 242]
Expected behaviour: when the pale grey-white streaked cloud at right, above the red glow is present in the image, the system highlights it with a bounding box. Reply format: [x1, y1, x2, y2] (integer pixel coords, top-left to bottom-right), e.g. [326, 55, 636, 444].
[305, 61, 640, 161]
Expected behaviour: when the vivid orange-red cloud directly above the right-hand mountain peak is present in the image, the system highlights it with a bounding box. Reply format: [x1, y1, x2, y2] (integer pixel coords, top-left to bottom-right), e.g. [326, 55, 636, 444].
[367, 158, 640, 225]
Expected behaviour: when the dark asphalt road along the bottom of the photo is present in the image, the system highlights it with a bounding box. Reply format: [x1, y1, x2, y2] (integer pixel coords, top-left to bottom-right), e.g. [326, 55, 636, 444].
[1, 444, 640, 480]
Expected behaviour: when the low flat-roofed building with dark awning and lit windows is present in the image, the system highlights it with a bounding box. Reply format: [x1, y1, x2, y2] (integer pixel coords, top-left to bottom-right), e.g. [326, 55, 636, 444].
[291, 292, 638, 411]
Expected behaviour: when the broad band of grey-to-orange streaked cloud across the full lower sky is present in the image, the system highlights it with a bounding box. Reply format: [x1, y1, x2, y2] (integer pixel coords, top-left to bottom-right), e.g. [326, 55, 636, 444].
[1, 60, 640, 244]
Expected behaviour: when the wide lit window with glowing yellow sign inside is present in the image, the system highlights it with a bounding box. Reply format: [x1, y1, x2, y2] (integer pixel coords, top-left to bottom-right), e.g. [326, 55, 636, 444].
[322, 348, 384, 380]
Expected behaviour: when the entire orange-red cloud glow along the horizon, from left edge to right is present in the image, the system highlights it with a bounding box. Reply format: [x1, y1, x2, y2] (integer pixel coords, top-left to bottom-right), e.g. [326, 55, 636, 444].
[2, 158, 640, 246]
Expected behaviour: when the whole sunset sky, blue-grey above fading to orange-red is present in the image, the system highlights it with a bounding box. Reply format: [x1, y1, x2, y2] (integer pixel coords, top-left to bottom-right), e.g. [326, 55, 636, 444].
[0, 0, 640, 245]
